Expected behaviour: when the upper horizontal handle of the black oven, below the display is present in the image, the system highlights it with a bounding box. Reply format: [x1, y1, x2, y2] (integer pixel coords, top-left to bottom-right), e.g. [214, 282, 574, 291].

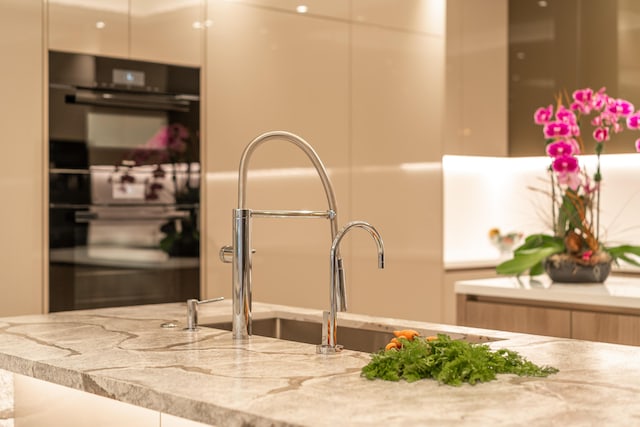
[64, 90, 193, 113]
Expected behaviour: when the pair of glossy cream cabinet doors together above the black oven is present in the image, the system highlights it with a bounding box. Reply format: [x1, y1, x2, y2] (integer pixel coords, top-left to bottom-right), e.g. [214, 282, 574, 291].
[48, 0, 205, 65]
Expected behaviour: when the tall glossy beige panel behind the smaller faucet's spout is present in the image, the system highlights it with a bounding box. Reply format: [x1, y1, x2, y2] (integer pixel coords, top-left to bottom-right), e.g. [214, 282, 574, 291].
[350, 0, 445, 321]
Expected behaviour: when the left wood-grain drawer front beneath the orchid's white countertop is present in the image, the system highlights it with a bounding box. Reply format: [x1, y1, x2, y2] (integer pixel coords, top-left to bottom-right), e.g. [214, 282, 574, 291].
[465, 301, 571, 338]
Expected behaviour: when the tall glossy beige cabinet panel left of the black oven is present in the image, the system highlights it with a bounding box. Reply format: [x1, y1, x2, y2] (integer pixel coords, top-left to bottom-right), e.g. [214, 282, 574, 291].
[0, 0, 44, 316]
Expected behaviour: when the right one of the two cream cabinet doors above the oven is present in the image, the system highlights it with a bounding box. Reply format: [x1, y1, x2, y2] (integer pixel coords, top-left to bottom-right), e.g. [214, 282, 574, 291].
[130, 0, 206, 66]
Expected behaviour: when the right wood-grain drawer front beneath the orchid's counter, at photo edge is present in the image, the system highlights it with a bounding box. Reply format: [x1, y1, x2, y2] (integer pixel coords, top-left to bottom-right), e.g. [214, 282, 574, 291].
[571, 311, 640, 345]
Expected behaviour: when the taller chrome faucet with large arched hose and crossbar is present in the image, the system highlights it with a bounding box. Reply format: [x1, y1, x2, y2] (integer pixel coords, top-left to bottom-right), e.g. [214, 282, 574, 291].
[220, 131, 346, 339]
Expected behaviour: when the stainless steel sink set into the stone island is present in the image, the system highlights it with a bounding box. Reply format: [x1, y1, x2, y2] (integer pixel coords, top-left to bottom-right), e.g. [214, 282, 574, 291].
[200, 317, 499, 353]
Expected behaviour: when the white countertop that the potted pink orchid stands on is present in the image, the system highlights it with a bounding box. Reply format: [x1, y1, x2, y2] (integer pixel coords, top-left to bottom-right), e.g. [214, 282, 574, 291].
[455, 275, 640, 309]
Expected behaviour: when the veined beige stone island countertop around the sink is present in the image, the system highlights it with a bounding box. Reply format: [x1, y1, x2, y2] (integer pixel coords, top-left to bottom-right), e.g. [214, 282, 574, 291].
[0, 301, 640, 426]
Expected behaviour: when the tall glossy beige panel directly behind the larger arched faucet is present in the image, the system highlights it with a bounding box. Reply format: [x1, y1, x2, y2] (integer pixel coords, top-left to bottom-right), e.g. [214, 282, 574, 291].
[205, 0, 350, 308]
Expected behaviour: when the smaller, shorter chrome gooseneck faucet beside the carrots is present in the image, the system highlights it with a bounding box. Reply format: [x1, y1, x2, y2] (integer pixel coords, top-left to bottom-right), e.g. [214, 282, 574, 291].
[316, 221, 384, 354]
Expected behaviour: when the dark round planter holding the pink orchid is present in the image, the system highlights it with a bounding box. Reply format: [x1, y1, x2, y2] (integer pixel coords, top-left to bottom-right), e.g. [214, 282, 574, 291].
[544, 255, 612, 283]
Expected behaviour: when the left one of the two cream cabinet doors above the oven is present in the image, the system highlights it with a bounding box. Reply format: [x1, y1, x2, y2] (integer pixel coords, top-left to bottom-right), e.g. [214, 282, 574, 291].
[48, 0, 129, 58]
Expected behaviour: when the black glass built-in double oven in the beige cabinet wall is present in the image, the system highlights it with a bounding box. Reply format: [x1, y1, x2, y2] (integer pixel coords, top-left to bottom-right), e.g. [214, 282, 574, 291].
[48, 51, 200, 311]
